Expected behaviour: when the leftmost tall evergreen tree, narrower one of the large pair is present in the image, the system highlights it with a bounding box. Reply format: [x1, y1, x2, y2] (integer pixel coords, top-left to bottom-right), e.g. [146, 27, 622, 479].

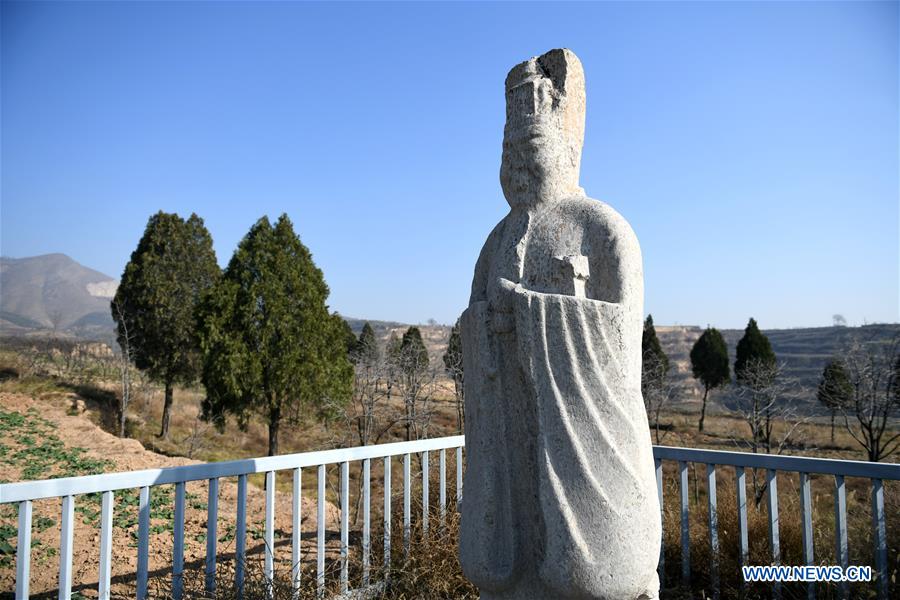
[111, 211, 220, 438]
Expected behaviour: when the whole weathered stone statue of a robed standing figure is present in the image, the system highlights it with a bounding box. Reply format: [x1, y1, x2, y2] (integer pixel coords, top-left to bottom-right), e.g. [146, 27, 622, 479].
[460, 50, 660, 600]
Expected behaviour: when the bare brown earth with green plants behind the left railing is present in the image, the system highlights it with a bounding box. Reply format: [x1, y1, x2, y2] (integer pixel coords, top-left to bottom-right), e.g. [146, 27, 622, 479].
[0, 393, 340, 597]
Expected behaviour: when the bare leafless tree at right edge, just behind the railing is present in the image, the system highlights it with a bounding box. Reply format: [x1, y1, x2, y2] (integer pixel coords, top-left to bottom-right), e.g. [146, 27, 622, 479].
[841, 335, 900, 462]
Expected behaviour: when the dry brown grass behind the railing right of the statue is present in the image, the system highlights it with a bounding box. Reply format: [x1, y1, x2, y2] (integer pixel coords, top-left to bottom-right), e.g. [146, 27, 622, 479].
[664, 465, 900, 598]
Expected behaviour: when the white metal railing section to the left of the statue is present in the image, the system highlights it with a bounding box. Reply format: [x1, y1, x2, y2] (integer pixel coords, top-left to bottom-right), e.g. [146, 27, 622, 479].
[0, 435, 465, 600]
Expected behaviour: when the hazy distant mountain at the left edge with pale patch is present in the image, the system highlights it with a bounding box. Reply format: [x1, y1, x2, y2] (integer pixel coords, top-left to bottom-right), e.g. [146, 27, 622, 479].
[0, 254, 118, 333]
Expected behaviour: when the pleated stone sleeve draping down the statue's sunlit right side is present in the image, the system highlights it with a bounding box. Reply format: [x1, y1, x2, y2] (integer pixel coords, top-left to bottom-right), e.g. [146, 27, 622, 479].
[515, 291, 660, 598]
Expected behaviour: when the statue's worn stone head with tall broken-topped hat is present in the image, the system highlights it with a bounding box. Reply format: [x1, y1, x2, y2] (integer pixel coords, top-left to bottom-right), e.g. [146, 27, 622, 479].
[500, 48, 585, 207]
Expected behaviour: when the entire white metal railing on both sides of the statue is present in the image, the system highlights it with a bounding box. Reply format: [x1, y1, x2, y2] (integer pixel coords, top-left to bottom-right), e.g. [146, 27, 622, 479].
[0, 436, 900, 600]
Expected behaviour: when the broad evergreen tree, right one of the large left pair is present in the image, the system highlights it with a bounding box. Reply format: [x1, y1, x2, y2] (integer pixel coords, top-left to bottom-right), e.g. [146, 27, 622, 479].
[198, 215, 353, 456]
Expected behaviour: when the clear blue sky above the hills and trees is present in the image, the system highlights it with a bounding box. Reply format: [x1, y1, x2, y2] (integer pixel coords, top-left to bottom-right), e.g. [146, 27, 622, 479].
[0, 2, 900, 328]
